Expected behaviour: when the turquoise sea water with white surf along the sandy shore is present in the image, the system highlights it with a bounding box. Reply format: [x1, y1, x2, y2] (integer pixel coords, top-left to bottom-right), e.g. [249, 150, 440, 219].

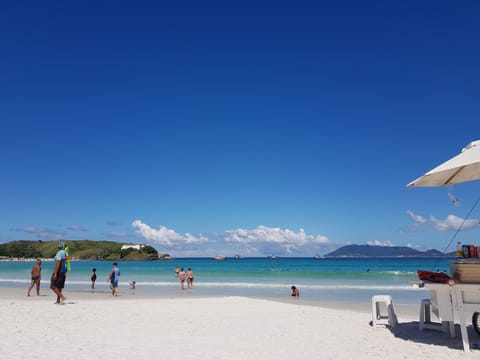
[0, 258, 453, 304]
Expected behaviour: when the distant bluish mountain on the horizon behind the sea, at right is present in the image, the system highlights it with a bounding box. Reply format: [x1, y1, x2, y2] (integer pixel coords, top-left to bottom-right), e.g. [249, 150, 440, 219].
[325, 245, 452, 257]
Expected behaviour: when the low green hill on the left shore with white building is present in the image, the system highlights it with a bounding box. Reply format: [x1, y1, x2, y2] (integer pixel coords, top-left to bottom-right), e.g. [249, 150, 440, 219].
[0, 240, 166, 260]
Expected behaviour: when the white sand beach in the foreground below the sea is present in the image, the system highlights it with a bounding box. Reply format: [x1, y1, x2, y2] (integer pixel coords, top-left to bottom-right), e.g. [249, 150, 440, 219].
[0, 289, 480, 360]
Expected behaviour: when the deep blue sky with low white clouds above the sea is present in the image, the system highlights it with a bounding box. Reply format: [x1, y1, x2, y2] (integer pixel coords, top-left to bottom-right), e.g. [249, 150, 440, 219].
[0, 1, 480, 257]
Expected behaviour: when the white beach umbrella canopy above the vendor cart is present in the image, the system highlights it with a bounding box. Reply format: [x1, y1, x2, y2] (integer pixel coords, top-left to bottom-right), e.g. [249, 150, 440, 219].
[407, 140, 480, 186]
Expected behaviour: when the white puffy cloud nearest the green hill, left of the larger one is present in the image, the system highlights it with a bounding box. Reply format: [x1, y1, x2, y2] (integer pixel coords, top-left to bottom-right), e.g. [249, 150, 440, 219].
[132, 220, 208, 247]
